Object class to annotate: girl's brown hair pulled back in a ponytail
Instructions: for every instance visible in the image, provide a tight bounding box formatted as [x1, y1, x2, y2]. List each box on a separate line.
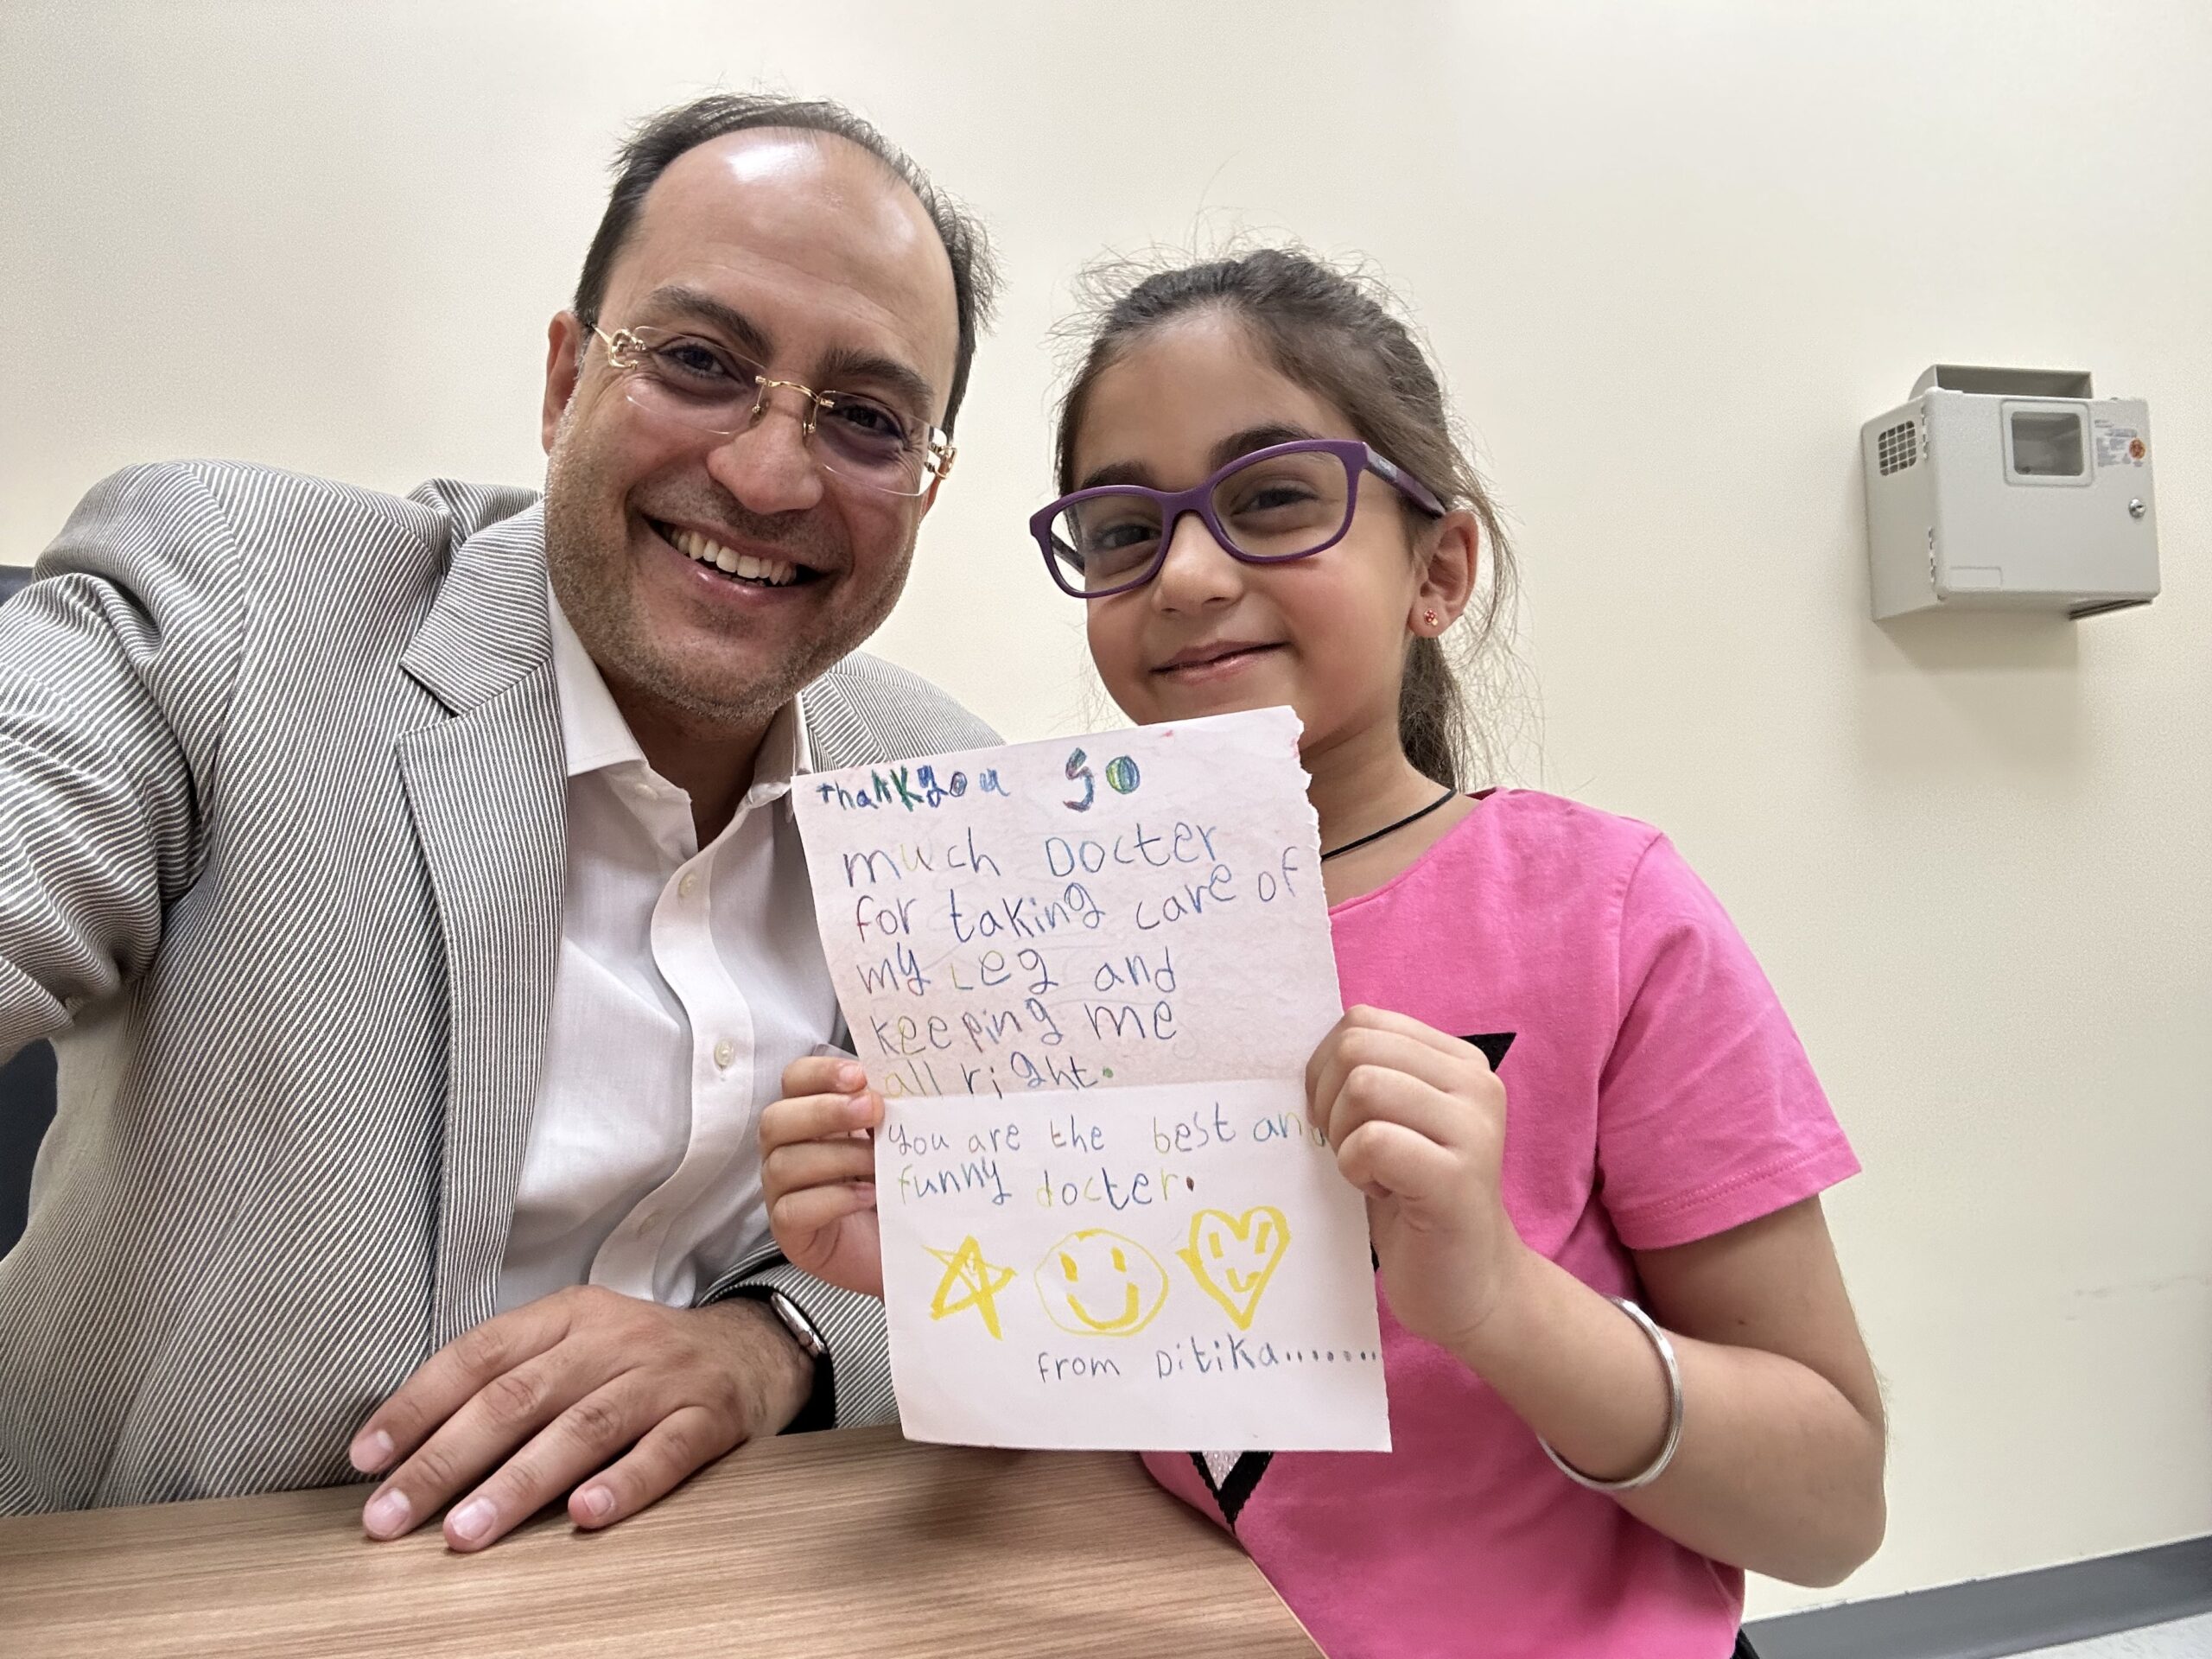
[1055, 248, 1513, 787]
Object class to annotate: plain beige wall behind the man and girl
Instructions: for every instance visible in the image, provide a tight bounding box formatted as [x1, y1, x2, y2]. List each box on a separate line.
[0, 0, 2212, 1611]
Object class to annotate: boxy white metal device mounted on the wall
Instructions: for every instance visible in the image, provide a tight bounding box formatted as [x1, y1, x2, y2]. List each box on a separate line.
[1858, 363, 2159, 621]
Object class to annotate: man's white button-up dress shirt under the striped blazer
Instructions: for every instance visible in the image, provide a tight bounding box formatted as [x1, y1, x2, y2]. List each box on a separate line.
[500, 600, 838, 1310]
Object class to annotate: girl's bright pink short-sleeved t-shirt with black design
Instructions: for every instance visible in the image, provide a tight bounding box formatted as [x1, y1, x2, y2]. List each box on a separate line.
[1146, 790, 1858, 1659]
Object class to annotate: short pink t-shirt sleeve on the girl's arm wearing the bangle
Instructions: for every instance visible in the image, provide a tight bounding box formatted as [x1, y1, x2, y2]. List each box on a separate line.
[1597, 836, 1858, 1249]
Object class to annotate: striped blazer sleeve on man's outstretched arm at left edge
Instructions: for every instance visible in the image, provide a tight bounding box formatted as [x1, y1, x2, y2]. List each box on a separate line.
[0, 465, 244, 1059]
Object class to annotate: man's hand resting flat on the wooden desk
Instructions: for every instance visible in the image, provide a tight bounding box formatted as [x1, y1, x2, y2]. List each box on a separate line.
[352, 1285, 814, 1551]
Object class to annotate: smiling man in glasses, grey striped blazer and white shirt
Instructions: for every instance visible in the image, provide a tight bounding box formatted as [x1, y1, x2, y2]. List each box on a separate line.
[0, 95, 993, 1548]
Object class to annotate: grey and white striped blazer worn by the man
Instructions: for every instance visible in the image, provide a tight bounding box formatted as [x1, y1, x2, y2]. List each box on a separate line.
[0, 462, 993, 1510]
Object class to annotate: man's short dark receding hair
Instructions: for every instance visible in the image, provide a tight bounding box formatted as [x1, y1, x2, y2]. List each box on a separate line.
[575, 93, 998, 431]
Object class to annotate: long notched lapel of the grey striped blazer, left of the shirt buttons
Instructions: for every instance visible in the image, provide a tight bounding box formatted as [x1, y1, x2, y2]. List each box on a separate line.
[398, 509, 569, 1347]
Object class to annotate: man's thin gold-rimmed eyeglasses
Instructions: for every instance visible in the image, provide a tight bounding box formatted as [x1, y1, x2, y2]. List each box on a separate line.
[591, 325, 953, 495]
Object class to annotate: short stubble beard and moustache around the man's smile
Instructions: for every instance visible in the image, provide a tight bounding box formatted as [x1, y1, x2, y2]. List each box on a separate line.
[544, 429, 918, 732]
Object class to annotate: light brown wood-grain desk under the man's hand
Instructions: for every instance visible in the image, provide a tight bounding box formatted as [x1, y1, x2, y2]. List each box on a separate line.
[0, 1429, 1316, 1659]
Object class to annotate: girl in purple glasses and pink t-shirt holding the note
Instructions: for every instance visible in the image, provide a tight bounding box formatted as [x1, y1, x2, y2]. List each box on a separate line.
[761, 252, 1883, 1659]
